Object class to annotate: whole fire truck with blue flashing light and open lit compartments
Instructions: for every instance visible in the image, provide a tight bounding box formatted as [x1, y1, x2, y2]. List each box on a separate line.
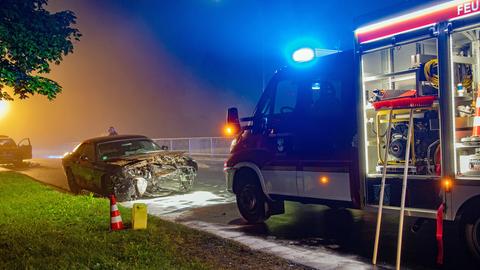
[224, 0, 480, 268]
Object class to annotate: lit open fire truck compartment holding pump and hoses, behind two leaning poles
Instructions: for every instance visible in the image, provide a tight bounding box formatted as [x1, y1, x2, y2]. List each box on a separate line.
[360, 36, 441, 211]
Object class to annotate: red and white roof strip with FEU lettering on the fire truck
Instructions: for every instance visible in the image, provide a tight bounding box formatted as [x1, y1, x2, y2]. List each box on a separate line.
[355, 0, 480, 43]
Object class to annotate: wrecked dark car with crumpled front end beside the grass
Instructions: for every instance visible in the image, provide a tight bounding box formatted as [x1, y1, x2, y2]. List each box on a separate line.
[62, 135, 198, 201]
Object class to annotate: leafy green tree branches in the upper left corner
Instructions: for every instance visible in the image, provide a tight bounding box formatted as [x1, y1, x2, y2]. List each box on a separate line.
[0, 0, 81, 100]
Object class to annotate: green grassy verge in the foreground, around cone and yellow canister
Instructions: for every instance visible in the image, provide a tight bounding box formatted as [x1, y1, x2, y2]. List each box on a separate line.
[0, 172, 306, 269]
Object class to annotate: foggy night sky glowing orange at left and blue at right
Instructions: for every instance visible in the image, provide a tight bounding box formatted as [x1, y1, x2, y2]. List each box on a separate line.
[0, 0, 442, 151]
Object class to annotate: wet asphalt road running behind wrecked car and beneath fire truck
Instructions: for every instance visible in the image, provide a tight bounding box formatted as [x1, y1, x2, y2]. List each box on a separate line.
[1, 157, 480, 269]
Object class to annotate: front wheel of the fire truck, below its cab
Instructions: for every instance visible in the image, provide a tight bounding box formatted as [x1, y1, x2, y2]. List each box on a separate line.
[236, 181, 268, 224]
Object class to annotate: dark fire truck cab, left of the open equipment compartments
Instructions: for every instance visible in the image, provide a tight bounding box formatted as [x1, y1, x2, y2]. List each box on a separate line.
[225, 51, 361, 223]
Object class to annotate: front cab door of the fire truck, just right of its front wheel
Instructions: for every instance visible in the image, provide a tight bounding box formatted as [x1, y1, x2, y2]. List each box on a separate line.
[261, 79, 300, 196]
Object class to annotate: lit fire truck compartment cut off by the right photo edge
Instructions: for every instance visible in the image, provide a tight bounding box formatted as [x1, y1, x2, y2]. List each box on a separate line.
[450, 25, 480, 179]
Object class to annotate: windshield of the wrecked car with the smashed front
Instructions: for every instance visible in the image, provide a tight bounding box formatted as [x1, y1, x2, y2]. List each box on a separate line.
[98, 139, 161, 161]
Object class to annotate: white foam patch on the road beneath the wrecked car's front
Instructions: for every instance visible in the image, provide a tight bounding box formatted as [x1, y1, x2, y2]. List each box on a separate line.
[122, 191, 235, 217]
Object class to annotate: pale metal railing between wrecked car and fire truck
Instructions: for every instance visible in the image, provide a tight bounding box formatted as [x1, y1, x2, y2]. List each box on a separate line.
[153, 137, 232, 156]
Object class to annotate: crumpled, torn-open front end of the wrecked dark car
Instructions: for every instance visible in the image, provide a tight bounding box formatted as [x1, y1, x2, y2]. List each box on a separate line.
[110, 152, 198, 201]
